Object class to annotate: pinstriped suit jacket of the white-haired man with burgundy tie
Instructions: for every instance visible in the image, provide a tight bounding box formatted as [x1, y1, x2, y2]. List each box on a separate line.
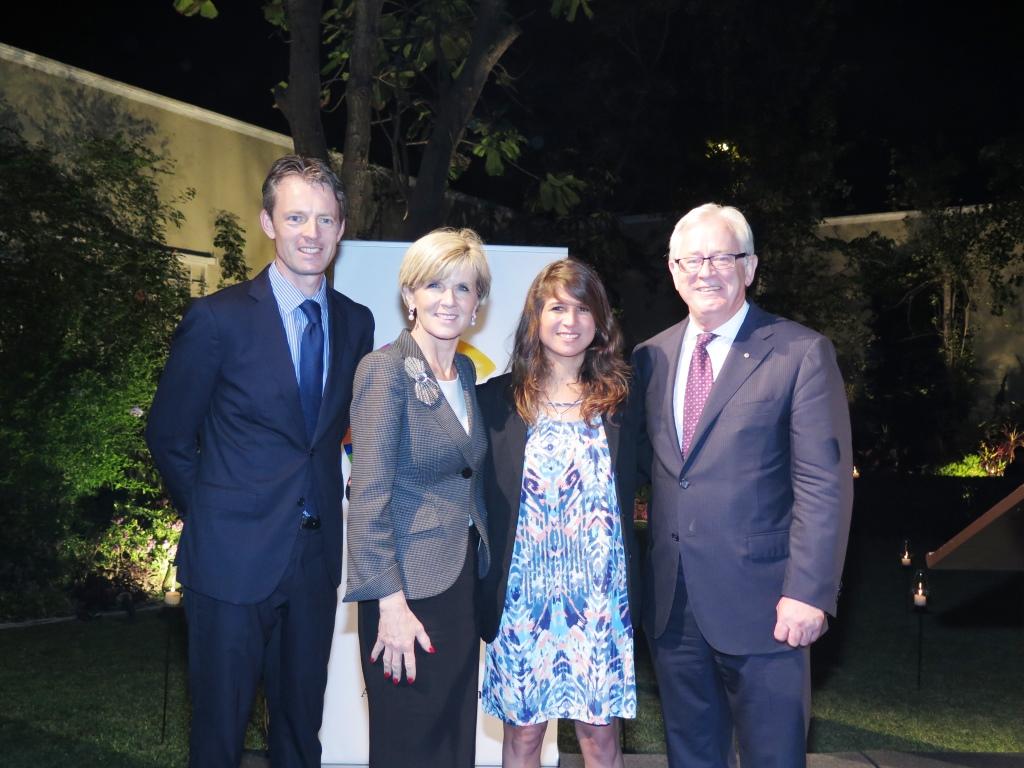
[633, 304, 853, 654]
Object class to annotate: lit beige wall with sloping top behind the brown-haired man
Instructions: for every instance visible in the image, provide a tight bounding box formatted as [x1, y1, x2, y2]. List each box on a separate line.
[0, 44, 292, 289]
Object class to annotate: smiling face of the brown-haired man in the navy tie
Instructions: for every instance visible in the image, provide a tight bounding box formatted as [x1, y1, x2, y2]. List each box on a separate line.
[259, 175, 345, 296]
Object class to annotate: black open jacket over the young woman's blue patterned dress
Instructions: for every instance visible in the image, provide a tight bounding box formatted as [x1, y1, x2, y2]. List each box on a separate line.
[477, 374, 640, 642]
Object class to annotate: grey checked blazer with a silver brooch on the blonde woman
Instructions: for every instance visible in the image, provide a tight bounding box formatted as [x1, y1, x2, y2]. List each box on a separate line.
[345, 331, 490, 602]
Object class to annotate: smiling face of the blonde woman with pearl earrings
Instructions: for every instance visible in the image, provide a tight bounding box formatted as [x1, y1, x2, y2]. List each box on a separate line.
[401, 266, 479, 341]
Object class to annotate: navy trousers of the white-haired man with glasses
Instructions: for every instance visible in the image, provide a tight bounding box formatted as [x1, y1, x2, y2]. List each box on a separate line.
[650, 567, 811, 768]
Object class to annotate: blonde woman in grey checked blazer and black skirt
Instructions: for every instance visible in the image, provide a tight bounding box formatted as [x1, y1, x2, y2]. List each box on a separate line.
[345, 229, 490, 768]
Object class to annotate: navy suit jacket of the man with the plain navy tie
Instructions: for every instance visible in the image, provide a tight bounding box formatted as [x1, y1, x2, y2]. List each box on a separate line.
[145, 267, 374, 604]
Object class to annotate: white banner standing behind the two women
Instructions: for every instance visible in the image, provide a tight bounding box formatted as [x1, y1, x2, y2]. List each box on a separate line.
[319, 241, 568, 766]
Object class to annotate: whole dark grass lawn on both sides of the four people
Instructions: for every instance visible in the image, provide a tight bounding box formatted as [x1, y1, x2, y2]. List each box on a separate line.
[0, 541, 1024, 768]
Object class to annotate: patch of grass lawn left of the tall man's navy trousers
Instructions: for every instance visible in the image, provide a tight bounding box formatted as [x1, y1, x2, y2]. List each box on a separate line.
[0, 611, 188, 768]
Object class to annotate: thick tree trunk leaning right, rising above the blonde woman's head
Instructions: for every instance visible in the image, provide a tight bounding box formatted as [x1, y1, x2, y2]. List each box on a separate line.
[402, 0, 520, 240]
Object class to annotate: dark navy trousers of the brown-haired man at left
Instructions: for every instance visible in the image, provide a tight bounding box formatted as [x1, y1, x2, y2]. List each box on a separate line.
[184, 523, 338, 768]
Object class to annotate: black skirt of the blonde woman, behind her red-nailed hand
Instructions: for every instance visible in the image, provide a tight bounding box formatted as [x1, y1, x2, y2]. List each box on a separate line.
[358, 532, 480, 768]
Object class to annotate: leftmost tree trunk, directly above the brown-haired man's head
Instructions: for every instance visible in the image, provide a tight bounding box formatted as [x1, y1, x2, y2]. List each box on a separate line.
[273, 0, 328, 160]
